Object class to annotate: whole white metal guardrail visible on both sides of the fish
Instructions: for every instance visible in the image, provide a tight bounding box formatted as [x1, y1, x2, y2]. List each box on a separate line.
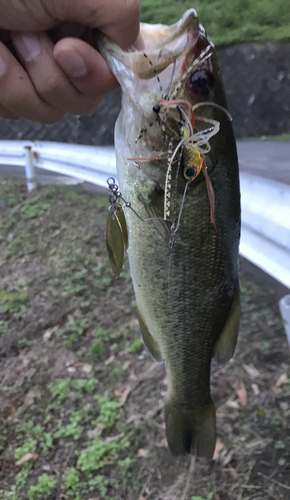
[0, 141, 290, 294]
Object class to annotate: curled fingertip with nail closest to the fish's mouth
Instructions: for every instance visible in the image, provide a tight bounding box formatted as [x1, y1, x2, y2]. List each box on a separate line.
[54, 38, 118, 100]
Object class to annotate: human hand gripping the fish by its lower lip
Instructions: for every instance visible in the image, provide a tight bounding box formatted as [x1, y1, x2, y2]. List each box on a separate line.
[0, 0, 140, 123]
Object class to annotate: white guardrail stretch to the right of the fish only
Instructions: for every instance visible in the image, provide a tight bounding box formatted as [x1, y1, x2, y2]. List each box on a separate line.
[240, 173, 290, 288]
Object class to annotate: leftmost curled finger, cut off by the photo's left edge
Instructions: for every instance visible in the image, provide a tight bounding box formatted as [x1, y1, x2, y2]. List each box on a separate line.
[0, 43, 63, 123]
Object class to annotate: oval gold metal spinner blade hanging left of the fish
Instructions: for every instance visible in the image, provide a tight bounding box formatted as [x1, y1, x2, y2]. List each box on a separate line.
[106, 207, 128, 278]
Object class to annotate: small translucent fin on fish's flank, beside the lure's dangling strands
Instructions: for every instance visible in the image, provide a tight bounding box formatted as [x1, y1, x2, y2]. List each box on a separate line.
[139, 187, 172, 242]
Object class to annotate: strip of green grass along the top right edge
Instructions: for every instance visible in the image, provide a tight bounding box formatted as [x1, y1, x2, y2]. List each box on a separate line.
[141, 0, 290, 45]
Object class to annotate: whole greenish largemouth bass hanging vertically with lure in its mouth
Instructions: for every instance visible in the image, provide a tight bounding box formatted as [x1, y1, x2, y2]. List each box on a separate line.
[96, 9, 240, 459]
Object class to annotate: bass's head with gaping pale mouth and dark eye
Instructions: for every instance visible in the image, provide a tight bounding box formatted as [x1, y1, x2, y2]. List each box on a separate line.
[97, 9, 231, 156]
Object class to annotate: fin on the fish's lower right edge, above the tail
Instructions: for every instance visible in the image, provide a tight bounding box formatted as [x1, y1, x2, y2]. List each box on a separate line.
[214, 288, 241, 365]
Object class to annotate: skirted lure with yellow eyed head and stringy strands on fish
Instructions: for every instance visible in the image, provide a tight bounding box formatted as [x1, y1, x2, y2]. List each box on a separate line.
[128, 47, 231, 249]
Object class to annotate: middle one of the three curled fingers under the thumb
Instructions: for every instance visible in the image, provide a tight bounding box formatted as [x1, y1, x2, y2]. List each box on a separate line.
[12, 33, 103, 114]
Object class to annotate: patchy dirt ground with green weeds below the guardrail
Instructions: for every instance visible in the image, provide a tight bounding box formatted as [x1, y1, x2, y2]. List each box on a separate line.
[0, 179, 290, 500]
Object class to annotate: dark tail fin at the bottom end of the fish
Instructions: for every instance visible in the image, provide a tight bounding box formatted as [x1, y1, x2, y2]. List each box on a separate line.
[165, 400, 216, 460]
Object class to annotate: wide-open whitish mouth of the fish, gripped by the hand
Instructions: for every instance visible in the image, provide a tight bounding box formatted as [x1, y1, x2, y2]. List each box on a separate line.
[97, 9, 211, 97]
